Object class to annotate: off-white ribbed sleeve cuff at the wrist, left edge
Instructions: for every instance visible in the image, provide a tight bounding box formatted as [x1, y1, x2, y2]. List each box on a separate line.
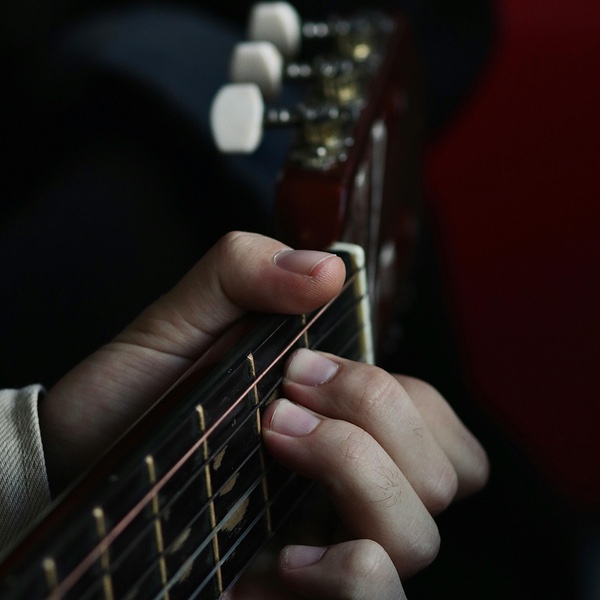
[0, 385, 50, 554]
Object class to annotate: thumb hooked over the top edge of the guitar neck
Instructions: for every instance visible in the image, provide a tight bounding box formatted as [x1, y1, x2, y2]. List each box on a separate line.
[40, 232, 344, 480]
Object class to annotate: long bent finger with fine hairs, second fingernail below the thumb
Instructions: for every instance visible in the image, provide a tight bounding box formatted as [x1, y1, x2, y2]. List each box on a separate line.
[263, 400, 439, 575]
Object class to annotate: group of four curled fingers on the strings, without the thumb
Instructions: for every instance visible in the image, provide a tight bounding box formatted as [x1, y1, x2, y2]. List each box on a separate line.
[231, 349, 488, 600]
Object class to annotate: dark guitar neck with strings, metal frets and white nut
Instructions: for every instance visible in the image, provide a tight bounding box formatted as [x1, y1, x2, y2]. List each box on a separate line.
[0, 245, 370, 600]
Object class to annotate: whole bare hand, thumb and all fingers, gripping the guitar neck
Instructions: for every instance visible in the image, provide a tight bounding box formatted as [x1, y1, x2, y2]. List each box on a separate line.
[40, 232, 488, 600]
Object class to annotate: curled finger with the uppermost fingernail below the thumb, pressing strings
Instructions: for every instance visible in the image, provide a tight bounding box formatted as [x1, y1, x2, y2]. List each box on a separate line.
[284, 349, 457, 514]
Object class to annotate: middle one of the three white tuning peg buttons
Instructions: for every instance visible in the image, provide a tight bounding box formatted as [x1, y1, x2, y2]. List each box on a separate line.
[229, 42, 283, 98]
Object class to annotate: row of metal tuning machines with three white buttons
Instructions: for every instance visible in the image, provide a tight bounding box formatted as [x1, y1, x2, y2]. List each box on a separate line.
[211, 2, 395, 170]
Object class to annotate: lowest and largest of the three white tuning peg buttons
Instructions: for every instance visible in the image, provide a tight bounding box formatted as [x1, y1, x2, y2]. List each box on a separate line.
[210, 83, 265, 154]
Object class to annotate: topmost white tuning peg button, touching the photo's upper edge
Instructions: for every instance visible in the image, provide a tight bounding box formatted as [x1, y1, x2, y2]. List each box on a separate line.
[248, 2, 302, 58]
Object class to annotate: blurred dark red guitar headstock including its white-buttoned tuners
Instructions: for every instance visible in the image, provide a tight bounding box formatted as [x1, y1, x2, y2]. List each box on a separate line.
[213, 2, 422, 348]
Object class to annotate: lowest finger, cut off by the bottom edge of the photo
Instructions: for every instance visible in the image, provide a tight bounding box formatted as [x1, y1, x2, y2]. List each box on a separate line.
[279, 540, 406, 600]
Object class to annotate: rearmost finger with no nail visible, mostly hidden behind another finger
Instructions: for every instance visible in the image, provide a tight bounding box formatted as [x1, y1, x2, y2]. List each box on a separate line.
[394, 375, 489, 498]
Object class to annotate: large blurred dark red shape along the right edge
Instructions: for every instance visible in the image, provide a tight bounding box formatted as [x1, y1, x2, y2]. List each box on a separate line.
[427, 0, 600, 510]
